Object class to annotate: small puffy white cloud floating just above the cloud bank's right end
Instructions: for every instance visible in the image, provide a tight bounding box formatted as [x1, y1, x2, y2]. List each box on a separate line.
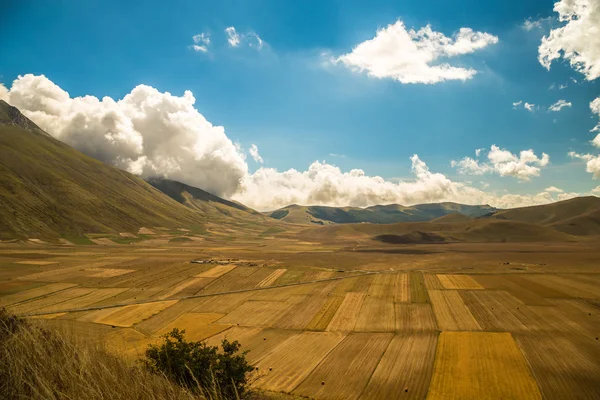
[450, 145, 550, 181]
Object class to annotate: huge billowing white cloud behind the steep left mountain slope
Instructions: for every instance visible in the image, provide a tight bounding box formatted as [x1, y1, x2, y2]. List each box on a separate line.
[3, 75, 248, 196]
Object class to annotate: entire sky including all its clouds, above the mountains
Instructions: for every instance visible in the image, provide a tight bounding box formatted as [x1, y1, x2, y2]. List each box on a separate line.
[0, 0, 600, 210]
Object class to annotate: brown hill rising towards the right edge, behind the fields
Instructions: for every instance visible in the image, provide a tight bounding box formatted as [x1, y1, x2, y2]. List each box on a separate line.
[488, 196, 600, 236]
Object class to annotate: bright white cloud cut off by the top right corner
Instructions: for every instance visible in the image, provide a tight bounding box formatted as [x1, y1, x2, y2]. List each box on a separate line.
[538, 0, 600, 80]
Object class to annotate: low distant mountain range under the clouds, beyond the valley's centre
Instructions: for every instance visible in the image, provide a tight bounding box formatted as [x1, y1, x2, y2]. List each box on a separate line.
[265, 202, 497, 225]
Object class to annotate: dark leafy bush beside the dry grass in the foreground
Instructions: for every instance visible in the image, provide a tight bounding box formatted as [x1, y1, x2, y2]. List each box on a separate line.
[144, 328, 254, 399]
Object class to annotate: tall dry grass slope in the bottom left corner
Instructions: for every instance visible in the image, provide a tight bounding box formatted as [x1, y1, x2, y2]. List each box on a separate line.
[0, 310, 197, 400]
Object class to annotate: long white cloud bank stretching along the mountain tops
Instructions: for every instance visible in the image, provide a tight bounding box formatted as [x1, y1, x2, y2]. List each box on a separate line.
[0, 75, 580, 210]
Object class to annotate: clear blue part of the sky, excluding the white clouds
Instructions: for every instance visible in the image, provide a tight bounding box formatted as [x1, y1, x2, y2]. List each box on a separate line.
[0, 0, 600, 211]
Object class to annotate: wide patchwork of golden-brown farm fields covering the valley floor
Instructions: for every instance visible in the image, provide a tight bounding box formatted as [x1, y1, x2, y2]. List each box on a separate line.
[0, 239, 600, 400]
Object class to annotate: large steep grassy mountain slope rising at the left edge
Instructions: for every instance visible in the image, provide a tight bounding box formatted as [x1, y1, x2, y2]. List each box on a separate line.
[0, 101, 260, 239]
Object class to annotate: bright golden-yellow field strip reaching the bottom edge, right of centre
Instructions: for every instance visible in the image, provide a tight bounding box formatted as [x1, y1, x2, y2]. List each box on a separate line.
[427, 332, 542, 400]
